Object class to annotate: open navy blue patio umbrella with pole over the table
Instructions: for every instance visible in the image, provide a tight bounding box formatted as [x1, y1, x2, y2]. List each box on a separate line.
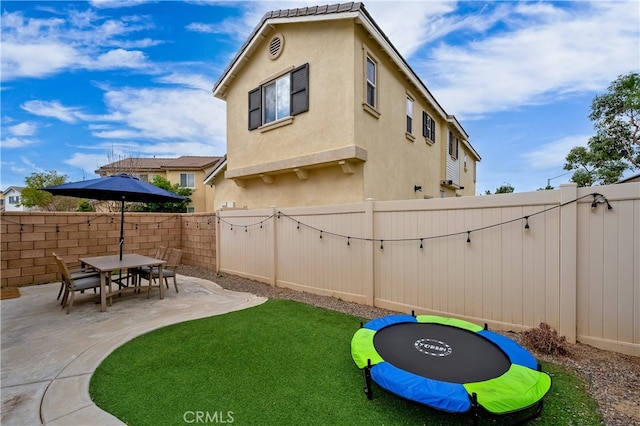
[42, 173, 186, 260]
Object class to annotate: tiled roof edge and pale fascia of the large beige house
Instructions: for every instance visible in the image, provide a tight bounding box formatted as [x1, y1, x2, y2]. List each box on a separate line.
[213, 2, 481, 160]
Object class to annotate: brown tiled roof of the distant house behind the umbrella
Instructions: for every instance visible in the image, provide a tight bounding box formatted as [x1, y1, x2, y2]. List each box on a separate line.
[96, 155, 220, 175]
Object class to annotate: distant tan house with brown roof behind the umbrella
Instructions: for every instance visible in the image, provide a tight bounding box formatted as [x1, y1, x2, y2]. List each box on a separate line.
[96, 155, 221, 213]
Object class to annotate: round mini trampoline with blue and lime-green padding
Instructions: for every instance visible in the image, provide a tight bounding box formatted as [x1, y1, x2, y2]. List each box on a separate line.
[351, 315, 551, 415]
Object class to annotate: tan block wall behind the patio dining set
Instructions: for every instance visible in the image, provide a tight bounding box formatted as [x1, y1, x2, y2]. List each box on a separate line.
[0, 212, 216, 288]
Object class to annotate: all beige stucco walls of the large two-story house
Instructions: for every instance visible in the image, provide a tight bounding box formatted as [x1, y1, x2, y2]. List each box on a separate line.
[213, 15, 475, 209]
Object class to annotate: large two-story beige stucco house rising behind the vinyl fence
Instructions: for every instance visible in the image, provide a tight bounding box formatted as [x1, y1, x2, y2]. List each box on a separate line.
[205, 3, 480, 209]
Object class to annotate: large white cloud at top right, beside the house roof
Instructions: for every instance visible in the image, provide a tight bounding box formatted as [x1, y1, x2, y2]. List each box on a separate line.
[416, 2, 640, 116]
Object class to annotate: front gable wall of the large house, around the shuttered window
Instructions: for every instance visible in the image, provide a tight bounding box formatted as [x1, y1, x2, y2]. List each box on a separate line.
[226, 21, 353, 170]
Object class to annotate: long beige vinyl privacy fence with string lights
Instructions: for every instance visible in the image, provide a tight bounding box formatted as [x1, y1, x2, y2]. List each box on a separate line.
[216, 183, 640, 356]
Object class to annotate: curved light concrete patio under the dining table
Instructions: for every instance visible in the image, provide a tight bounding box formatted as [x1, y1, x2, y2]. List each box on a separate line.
[0, 275, 266, 426]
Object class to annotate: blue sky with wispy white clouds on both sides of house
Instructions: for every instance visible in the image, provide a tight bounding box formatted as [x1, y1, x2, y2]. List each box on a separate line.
[0, 0, 640, 194]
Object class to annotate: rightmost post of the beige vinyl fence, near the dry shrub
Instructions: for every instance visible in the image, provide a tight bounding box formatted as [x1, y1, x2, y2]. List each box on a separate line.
[558, 183, 578, 343]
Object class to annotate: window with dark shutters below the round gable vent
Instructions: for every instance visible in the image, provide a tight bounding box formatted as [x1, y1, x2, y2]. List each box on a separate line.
[249, 64, 309, 130]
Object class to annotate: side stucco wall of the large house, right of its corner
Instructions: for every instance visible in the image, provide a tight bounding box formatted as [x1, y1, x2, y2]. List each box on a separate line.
[353, 26, 446, 200]
